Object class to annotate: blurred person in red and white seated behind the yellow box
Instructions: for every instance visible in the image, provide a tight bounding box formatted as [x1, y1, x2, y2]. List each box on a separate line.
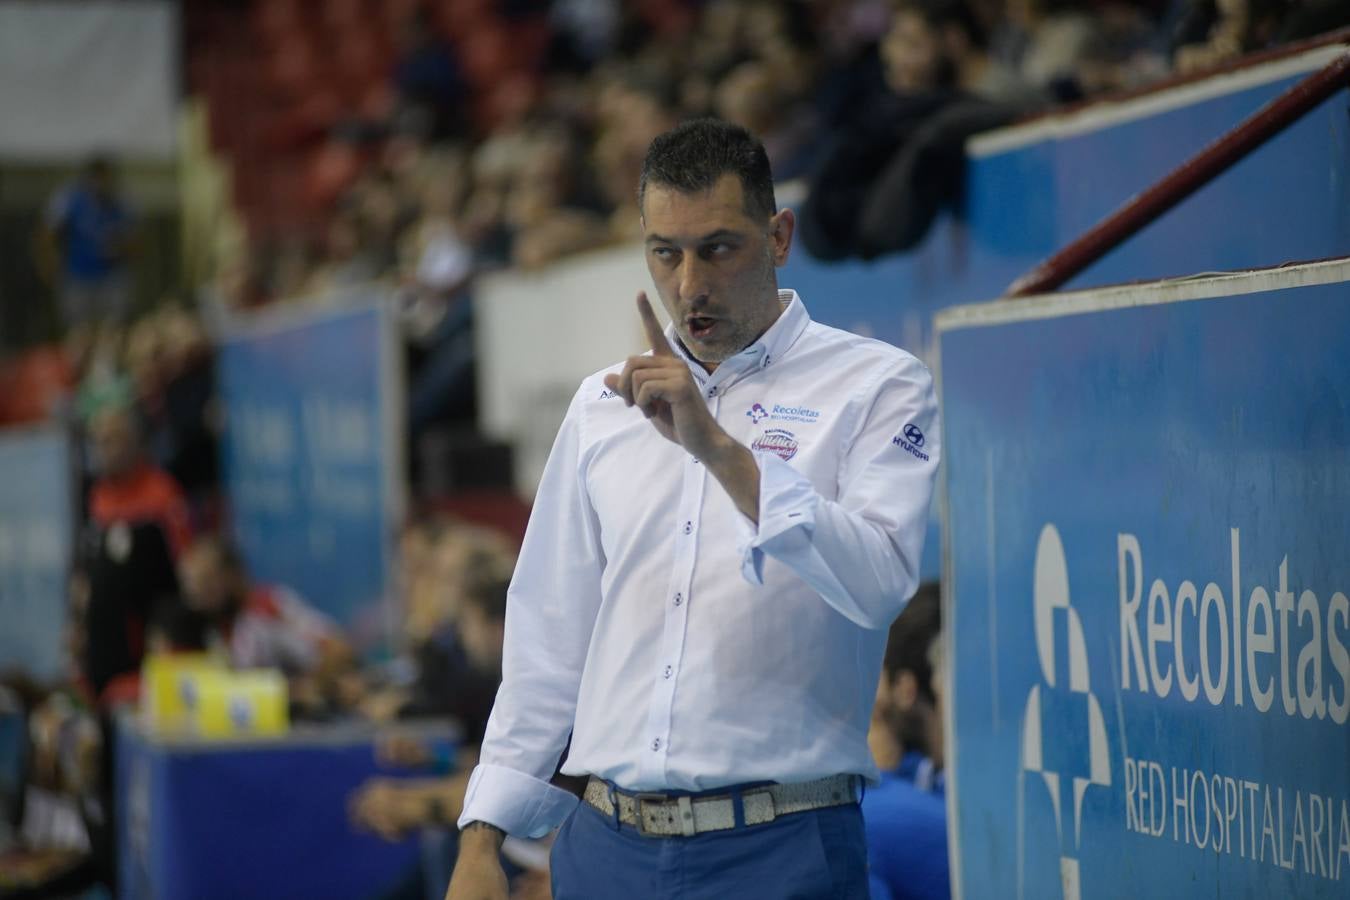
[180, 536, 348, 687]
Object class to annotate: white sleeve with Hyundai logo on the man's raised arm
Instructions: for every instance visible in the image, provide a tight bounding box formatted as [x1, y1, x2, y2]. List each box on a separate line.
[741, 356, 941, 629]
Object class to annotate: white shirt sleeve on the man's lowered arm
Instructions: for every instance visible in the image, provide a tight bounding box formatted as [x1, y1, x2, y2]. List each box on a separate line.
[459, 391, 603, 838]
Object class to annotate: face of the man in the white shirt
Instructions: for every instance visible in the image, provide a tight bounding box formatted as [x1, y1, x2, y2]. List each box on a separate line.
[643, 174, 794, 371]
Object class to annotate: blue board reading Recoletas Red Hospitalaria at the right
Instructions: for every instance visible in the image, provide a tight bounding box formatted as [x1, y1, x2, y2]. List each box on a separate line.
[938, 262, 1350, 899]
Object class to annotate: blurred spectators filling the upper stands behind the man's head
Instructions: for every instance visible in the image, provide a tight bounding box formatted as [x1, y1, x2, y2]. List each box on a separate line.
[205, 0, 1350, 306]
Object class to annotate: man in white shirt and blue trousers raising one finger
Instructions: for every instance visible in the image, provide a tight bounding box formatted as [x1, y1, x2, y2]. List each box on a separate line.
[448, 120, 938, 900]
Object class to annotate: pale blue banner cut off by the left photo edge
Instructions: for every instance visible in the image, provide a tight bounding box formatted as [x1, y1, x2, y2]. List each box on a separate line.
[0, 429, 74, 679]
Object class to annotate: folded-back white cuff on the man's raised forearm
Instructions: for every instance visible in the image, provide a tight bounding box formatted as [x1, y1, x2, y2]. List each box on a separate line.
[740, 451, 821, 584]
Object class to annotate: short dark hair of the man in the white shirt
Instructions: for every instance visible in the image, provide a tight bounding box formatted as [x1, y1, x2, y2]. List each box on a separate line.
[637, 119, 778, 219]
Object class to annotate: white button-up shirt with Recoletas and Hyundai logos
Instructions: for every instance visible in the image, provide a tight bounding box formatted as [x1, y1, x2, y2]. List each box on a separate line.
[460, 291, 938, 837]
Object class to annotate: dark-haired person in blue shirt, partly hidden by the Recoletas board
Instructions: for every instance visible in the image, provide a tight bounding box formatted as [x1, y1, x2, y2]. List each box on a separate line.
[863, 582, 952, 900]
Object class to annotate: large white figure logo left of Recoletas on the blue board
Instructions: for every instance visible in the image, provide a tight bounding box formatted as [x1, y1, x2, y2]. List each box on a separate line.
[1018, 525, 1111, 900]
